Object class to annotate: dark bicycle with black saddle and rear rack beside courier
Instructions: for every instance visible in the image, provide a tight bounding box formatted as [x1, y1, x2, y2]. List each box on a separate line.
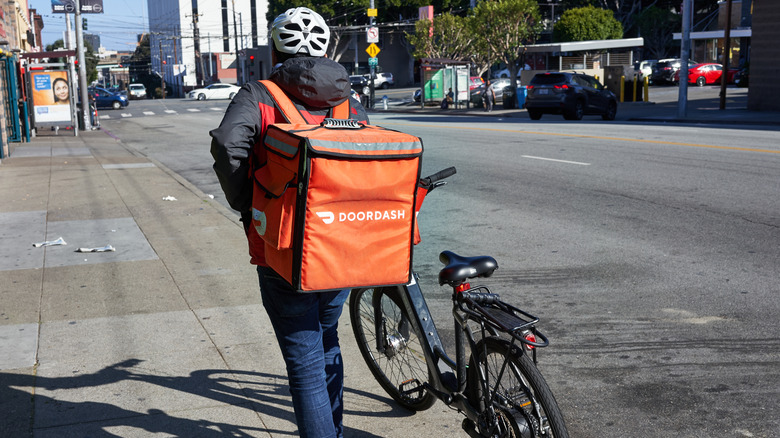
[349, 167, 568, 438]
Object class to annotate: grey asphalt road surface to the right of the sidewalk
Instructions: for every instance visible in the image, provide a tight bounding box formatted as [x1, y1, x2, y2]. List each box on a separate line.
[102, 96, 780, 437]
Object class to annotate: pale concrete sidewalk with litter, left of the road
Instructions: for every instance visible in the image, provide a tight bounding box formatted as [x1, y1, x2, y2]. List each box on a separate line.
[0, 131, 462, 437]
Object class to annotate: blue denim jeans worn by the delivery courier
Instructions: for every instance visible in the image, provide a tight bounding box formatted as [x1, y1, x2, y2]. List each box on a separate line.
[257, 266, 349, 438]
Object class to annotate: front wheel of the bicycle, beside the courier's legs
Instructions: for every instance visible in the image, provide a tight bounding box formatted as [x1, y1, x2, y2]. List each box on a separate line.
[349, 287, 436, 411]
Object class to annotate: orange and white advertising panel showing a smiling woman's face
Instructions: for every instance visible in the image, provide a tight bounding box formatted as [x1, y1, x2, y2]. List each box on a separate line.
[30, 71, 72, 123]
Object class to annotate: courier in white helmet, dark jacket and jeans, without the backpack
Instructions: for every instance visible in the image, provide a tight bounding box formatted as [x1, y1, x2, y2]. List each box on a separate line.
[210, 7, 368, 437]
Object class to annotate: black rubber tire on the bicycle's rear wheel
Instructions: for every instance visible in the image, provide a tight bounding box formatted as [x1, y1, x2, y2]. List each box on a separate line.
[466, 337, 569, 438]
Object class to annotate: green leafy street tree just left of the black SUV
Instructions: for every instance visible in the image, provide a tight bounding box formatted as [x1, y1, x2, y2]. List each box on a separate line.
[471, 0, 541, 89]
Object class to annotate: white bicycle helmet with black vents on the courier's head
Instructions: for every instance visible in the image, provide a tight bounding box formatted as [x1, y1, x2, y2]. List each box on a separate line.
[271, 7, 330, 56]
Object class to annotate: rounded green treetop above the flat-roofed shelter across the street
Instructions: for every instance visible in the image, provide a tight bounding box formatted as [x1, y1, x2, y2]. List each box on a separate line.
[553, 6, 623, 41]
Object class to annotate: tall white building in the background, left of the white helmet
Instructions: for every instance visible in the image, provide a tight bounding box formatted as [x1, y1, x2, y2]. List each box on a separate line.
[148, 0, 268, 96]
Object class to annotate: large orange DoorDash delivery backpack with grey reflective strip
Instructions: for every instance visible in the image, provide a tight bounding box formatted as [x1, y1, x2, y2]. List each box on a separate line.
[250, 81, 423, 292]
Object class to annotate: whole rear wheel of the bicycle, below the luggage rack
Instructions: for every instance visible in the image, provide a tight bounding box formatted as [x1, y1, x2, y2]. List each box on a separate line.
[466, 337, 569, 438]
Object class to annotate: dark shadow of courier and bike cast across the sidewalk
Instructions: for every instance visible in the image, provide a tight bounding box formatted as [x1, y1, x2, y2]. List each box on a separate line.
[0, 359, 413, 438]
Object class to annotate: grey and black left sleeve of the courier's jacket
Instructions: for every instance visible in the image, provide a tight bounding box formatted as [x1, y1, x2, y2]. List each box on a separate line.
[209, 85, 262, 213]
